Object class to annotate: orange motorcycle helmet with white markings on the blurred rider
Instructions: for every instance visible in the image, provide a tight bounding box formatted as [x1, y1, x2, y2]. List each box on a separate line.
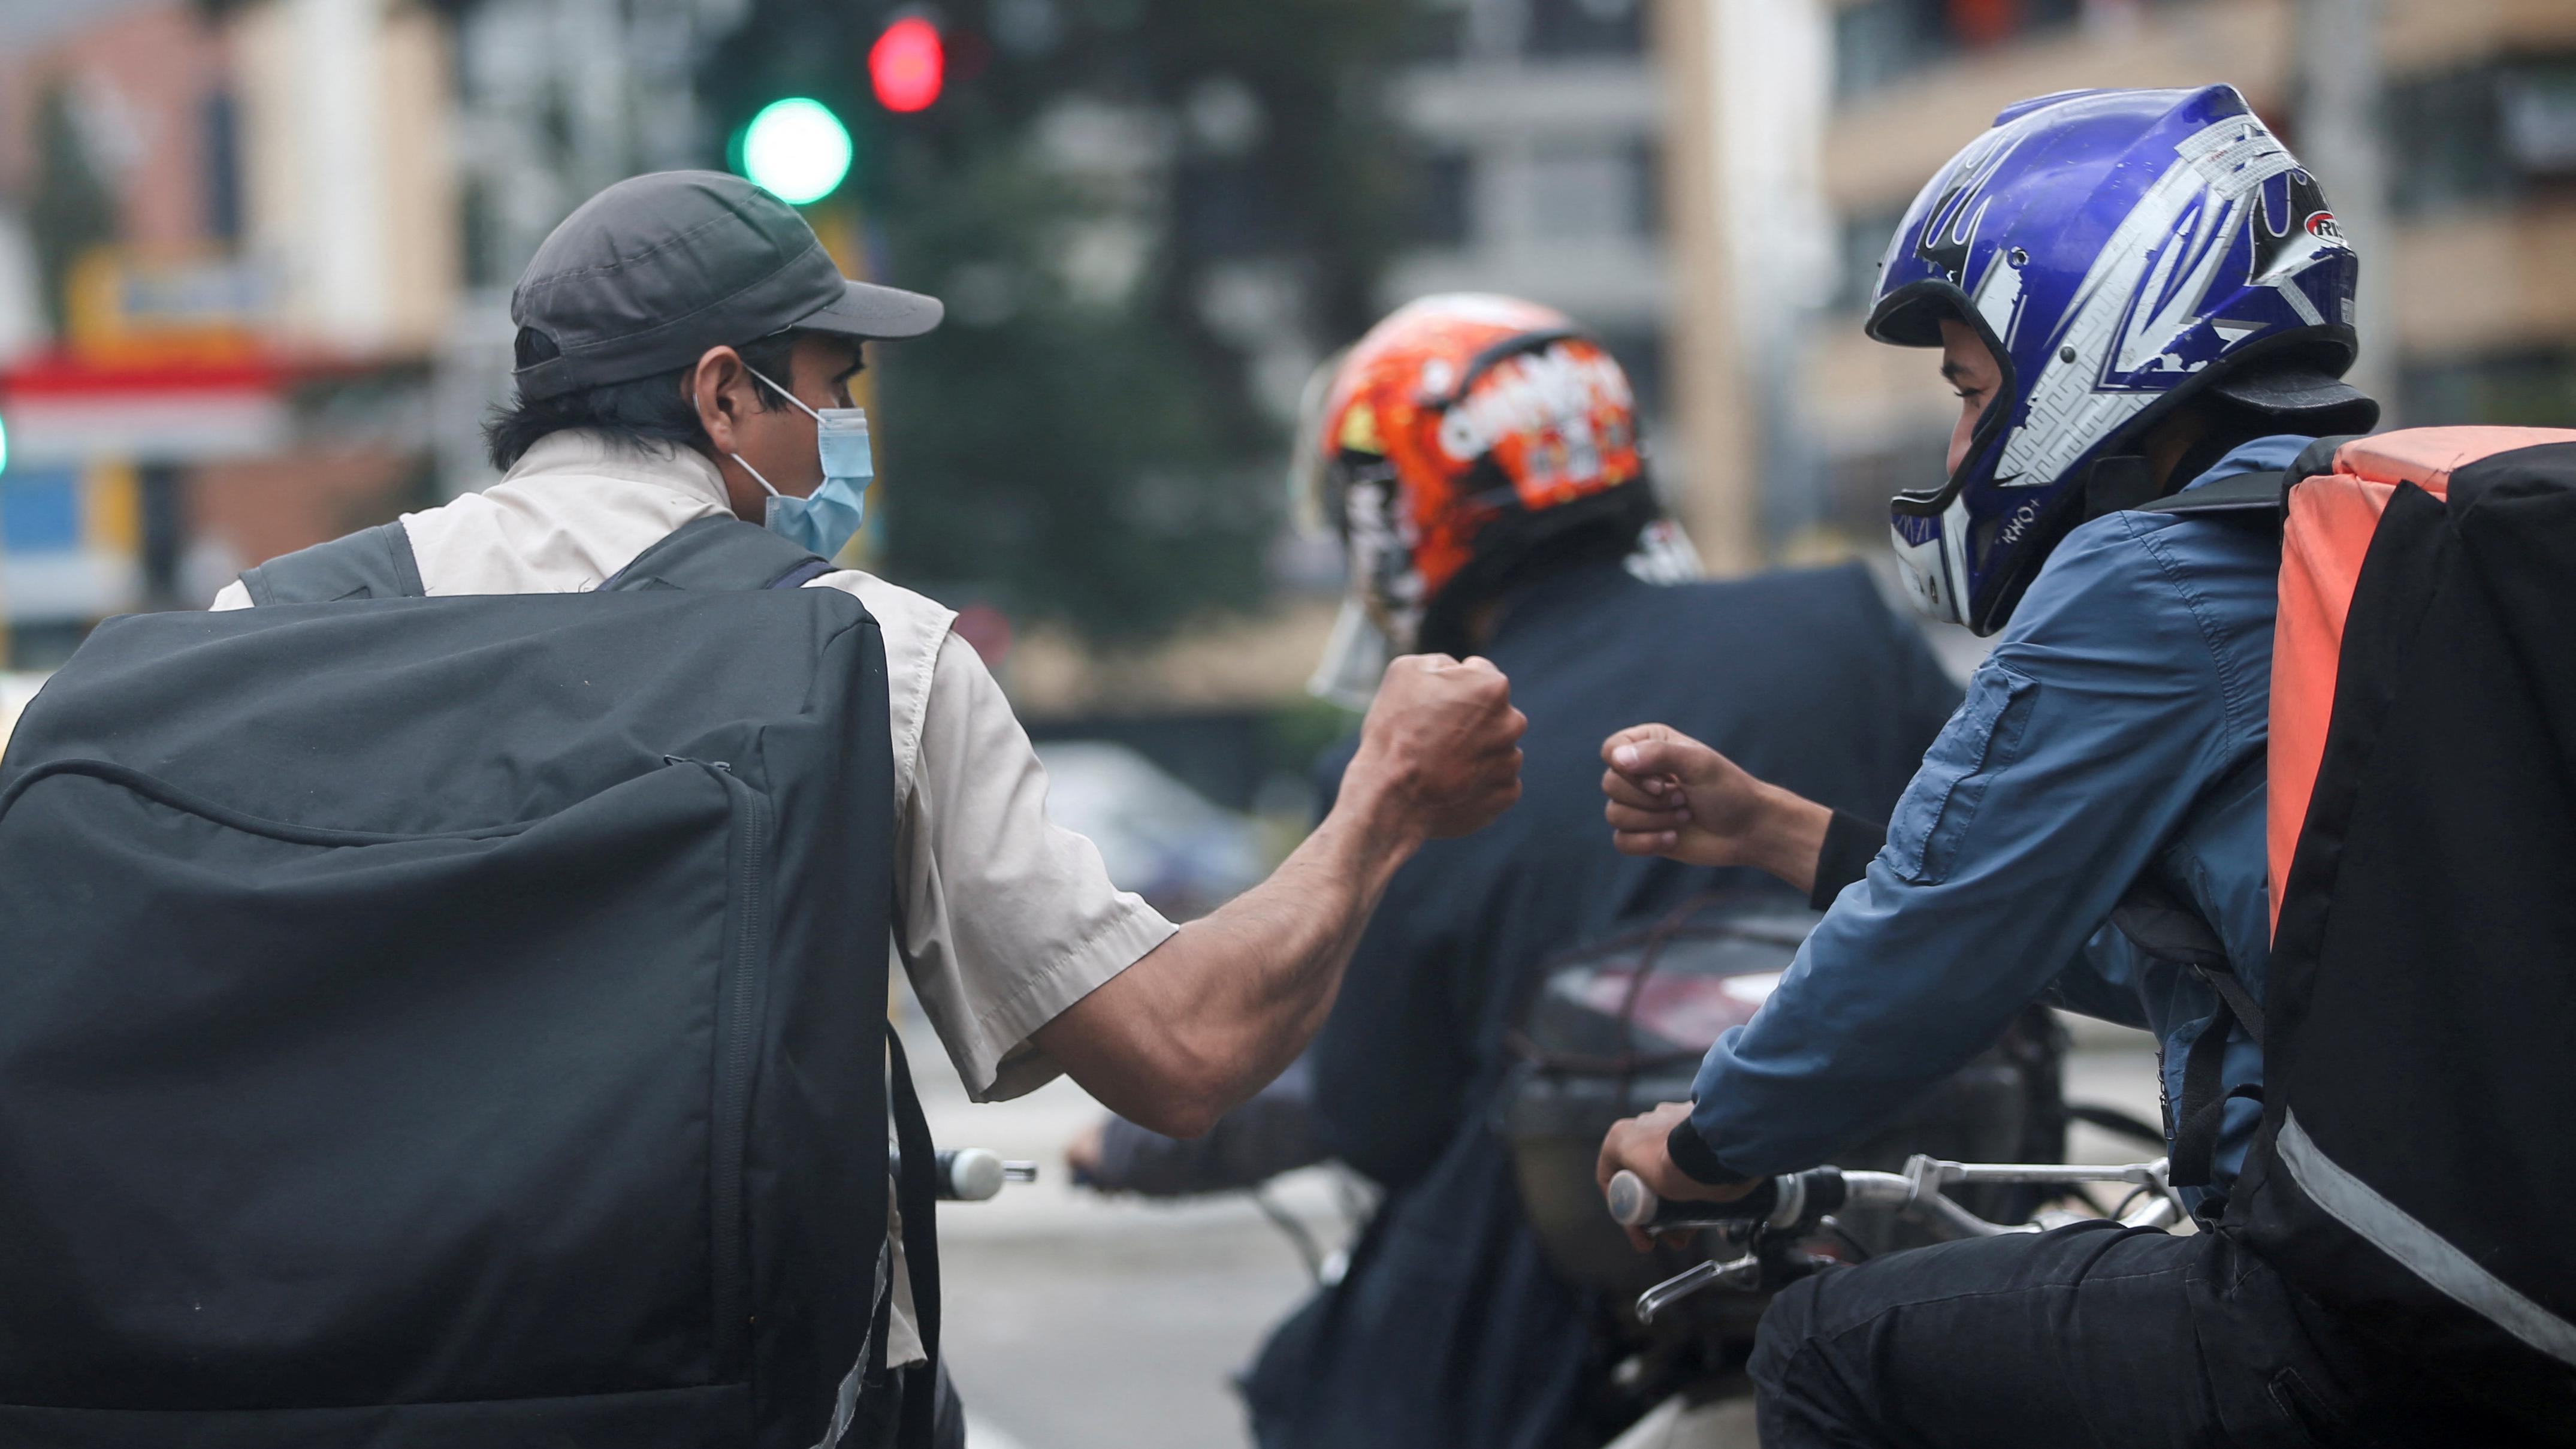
[1298, 294, 1659, 653]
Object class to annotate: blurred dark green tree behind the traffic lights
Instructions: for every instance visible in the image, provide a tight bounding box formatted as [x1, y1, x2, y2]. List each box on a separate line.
[700, 0, 1417, 645]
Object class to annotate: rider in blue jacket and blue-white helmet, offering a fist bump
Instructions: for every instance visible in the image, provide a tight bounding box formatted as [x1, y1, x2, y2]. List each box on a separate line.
[1600, 87, 2493, 1449]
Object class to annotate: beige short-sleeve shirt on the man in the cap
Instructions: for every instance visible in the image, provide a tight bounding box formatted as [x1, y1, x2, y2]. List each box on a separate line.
[214, 431, 1174, 1364]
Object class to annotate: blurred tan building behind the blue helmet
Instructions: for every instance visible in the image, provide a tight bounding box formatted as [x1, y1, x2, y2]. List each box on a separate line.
[1659, 0, 2576, 557]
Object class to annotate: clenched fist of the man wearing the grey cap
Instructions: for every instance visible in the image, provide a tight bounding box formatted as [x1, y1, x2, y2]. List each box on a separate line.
[1342, 655, 1530, 838]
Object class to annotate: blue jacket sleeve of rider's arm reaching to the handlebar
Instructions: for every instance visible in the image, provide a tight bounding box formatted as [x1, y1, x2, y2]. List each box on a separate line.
[1690, 513, 2262, 1178]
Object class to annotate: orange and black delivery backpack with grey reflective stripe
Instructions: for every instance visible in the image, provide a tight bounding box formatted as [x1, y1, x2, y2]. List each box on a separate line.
[2151, 428, 2576, 1431]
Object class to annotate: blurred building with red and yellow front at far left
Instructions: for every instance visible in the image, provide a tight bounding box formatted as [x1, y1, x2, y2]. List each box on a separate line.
[0, 0, 458, 668]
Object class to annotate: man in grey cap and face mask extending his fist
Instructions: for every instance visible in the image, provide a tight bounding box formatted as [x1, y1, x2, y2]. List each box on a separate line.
[216, 173, 1523, 1441]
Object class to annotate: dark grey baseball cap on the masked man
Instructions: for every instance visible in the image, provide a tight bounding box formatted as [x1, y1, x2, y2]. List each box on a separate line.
[510, 170, 940, 400]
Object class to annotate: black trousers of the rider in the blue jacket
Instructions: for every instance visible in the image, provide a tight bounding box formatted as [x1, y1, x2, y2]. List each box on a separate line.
[1751, 1222, 2530, 1449]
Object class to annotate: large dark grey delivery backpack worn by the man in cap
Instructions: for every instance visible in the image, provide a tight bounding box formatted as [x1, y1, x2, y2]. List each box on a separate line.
[0, 518, 938, 1449]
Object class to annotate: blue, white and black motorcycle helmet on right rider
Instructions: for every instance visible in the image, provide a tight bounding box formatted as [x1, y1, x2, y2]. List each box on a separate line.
[1868, 85, 2378, 634]
